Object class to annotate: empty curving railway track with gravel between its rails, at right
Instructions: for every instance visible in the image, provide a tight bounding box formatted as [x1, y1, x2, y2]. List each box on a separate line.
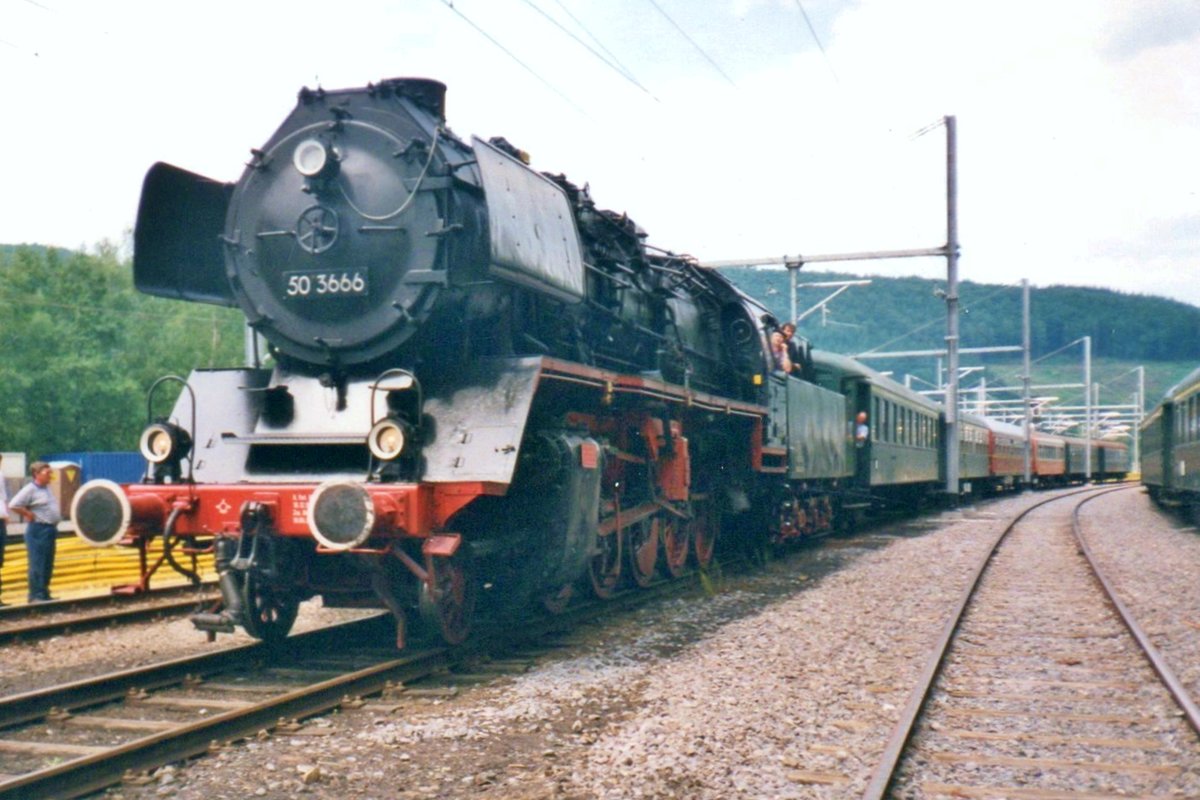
[863, 487, 1200, 800]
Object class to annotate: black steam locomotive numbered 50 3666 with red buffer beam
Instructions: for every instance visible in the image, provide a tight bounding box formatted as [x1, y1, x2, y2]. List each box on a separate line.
[73, 79, 777, 644]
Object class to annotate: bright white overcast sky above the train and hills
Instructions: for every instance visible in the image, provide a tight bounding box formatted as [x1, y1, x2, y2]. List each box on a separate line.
[0, 0, 1200, 305]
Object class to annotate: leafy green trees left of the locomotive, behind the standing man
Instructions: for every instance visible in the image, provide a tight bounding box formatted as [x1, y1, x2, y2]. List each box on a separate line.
[0, 243, 241, 457]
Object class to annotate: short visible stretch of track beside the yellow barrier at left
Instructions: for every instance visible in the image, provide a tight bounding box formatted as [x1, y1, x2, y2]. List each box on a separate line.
[0, 584, 220, 645]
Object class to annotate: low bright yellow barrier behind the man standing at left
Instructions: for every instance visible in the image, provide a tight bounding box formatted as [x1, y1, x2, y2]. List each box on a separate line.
[0, 532, 216, 603]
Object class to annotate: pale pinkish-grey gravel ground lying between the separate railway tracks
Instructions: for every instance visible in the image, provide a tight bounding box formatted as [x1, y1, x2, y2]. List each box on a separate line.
[7, 491, 1200, 800]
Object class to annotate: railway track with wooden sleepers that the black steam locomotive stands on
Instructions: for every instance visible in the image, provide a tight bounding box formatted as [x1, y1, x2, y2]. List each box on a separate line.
[0, 568, 698, 800]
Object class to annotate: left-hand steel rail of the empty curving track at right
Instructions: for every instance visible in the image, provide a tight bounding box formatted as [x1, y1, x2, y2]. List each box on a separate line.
[862, 486, 1128, 800]
